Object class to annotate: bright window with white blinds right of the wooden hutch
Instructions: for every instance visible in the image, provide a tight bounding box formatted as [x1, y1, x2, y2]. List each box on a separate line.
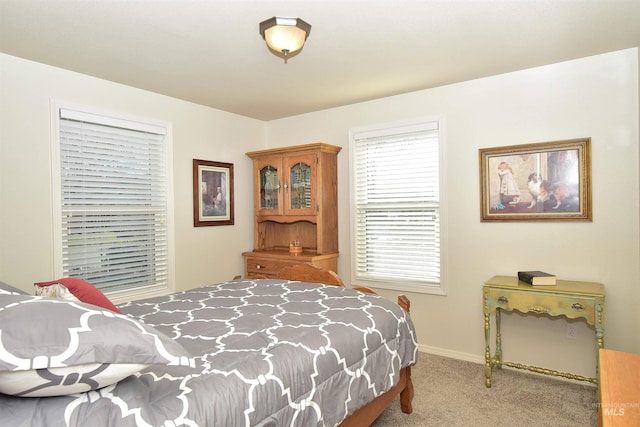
[351, 120, 444, 294]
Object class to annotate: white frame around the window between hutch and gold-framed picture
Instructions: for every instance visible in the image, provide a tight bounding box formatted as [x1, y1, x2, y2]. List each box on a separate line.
[349, 116, 447, 295]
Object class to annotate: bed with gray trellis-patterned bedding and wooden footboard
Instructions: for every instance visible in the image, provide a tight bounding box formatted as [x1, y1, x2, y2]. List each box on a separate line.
[0, 270, 418, 426]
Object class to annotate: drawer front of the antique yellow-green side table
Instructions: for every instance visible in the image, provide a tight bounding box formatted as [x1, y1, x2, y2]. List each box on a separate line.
[485, 289, 596, 325]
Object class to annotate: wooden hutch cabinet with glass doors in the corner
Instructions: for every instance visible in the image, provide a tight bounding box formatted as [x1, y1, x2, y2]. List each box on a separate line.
[242, 143, 341, 277]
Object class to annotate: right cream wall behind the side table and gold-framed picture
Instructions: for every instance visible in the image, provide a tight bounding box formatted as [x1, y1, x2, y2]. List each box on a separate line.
[267, 49, 640, 376]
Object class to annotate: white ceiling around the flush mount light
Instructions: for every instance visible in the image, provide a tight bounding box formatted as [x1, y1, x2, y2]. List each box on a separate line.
[0, 0, 640, 120]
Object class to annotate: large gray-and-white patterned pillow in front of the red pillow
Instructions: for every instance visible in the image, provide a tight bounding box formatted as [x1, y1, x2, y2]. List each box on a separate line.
[0, 293, 193, 396]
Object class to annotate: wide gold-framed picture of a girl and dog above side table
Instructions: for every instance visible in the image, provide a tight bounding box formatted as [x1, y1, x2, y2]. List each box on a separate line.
[479, 138, 592, 222]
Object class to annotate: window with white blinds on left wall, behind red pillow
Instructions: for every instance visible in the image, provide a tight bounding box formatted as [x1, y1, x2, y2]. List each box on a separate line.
[52, 105, 173, 299]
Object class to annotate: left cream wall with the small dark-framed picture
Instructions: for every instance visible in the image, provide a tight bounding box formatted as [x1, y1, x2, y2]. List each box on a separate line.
[0, 54, 265, 292]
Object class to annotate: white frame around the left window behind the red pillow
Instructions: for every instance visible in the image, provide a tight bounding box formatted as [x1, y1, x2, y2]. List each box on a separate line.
[50, 99, 175, 304]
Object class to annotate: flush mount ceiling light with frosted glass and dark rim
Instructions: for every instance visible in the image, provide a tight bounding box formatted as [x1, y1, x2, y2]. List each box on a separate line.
[260, 16, 311, 64]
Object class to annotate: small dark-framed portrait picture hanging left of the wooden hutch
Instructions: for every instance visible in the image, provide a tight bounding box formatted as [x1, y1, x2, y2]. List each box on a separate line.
[193, 159, 238, 227]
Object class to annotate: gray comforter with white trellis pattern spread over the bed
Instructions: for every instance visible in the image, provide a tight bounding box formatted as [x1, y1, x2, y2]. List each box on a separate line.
[0, 279, 418, 427]
